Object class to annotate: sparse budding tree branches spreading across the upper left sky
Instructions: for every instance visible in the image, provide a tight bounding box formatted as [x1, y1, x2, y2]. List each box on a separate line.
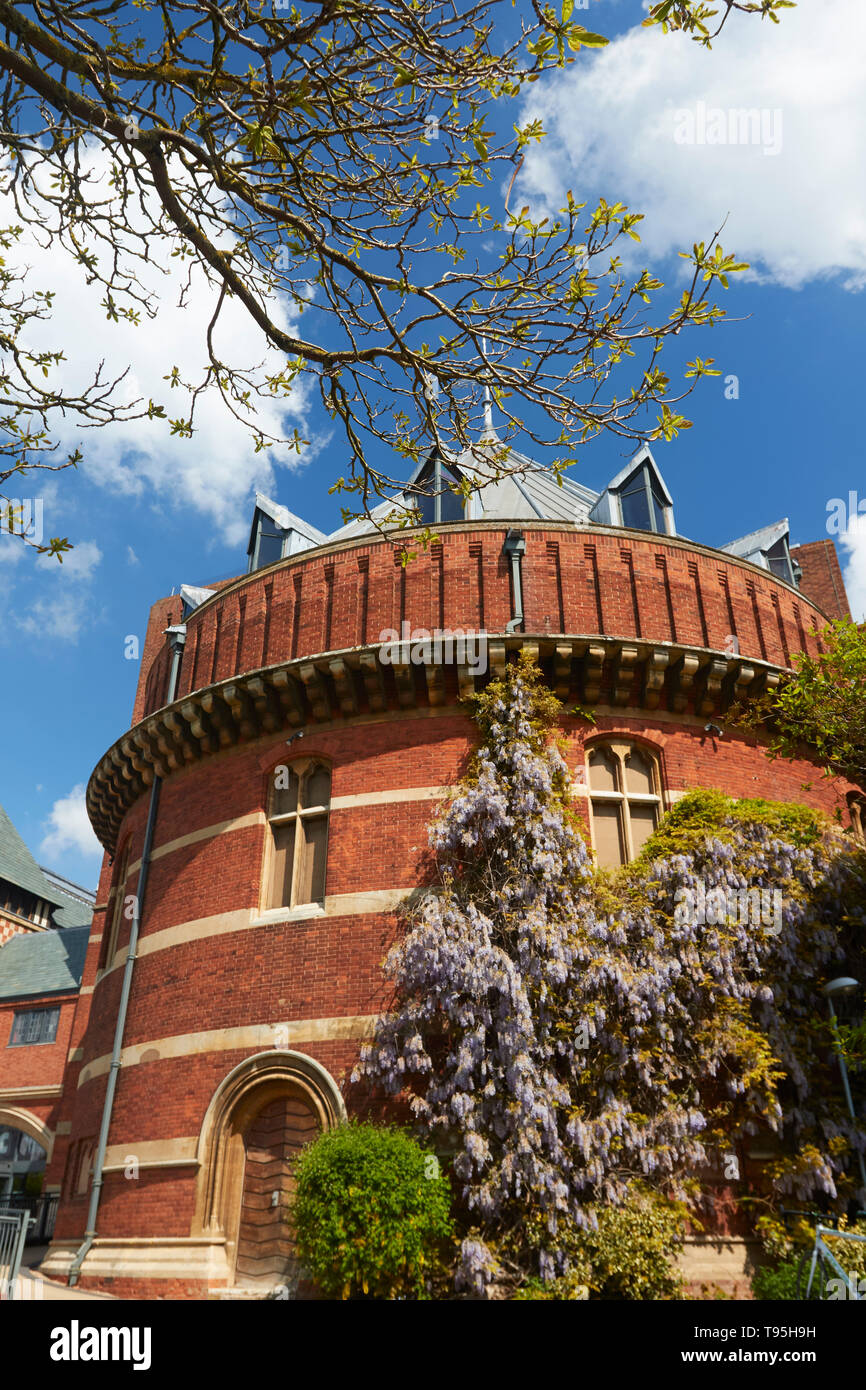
[0, 0, 788, 553]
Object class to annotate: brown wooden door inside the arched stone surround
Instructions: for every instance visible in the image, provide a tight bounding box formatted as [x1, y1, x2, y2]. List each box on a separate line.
[235, 1095, 318, 1286]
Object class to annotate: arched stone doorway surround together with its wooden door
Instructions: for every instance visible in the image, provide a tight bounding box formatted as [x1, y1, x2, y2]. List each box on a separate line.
[192, 1051, 346, 1286]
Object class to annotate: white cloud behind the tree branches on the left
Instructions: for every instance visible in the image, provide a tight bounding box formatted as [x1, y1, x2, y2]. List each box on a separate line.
[0, 150, 311, 544]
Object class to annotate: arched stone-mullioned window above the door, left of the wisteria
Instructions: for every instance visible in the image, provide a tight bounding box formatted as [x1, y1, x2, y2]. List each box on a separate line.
[265, 759, 331, 908]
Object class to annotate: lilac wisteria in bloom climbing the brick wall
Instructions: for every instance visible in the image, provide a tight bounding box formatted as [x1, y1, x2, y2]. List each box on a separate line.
[357, 660, 866, 1295]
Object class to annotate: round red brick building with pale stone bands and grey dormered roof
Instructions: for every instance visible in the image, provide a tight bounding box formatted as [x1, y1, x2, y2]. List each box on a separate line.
[32, 450, 859, 1297]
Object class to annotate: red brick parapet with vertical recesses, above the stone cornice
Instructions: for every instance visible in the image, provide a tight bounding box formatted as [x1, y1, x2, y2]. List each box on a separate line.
[133, 523, 844, 723]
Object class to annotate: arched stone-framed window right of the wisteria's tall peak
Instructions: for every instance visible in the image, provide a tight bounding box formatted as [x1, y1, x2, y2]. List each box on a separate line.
[587, 739, 662, 869]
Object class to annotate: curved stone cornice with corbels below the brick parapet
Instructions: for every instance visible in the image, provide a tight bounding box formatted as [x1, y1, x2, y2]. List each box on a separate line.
[88, 632, 784, 852]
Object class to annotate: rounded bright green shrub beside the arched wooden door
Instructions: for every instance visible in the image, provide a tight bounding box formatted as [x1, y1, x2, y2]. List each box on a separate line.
[292, 1123, 453, 1298]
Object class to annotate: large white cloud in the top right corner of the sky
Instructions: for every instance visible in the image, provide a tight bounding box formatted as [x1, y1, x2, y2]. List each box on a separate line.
[512, 0, 866, 289]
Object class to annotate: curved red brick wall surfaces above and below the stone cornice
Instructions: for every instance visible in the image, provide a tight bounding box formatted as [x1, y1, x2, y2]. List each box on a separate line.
[42, 524, 861, 1297]
